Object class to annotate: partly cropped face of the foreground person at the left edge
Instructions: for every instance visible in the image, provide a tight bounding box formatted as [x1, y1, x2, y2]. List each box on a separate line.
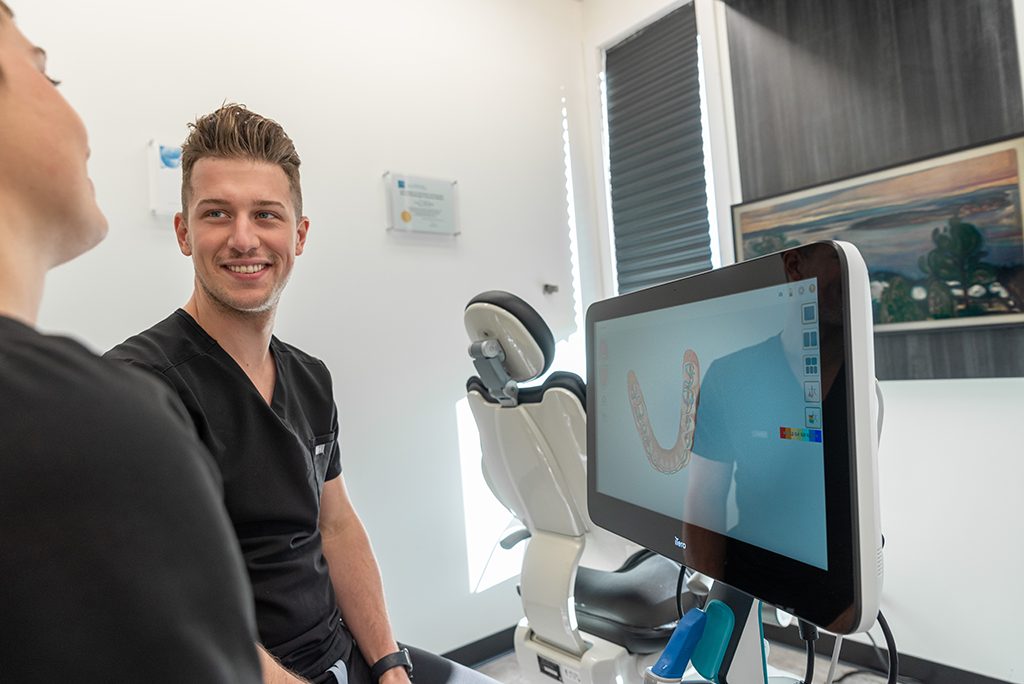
[0, 18, 106, 265]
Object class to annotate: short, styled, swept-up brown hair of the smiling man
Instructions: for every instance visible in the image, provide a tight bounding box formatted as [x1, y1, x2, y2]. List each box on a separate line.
[181, 104, 302, 221]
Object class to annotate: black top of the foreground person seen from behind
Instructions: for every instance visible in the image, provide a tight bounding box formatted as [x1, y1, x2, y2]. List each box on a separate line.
[0, 315, 262, 684]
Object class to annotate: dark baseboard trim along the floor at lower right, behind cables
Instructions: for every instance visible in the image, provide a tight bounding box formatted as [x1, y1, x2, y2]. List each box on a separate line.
[764, 625, 1011, 684]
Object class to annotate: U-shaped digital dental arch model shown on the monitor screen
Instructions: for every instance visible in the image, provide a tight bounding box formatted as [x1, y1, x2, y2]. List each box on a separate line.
[626, 349, 700, 475]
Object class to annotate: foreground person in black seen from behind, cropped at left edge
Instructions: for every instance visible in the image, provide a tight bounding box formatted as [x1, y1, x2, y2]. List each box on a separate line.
[0, 6, 260, 684]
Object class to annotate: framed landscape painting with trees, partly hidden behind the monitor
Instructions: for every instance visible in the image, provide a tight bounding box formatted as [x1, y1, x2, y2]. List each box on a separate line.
[732, 137, 1024, 332]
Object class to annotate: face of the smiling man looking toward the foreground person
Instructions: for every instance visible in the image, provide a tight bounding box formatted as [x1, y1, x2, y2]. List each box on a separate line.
[174, 158, 309, 314]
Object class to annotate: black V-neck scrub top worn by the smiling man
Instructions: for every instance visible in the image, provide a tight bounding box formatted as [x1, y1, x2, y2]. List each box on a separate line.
[106, 309, 352, 676]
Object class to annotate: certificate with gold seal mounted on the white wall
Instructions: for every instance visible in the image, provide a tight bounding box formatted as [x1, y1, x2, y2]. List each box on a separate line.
[384, 172, 459, 236]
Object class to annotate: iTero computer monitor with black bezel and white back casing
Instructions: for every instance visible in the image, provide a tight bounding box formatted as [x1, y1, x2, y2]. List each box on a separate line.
[587, 242, 882, 634]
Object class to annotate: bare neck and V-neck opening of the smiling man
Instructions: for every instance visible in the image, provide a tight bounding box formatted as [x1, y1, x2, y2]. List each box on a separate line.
[182, 286, 276, 403]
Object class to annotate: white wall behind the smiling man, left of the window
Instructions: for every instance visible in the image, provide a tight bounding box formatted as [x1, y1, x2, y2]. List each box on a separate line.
[19, 0, 589, 651]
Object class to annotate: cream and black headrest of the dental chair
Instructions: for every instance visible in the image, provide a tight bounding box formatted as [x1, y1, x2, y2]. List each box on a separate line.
[463, 290, 555, 382]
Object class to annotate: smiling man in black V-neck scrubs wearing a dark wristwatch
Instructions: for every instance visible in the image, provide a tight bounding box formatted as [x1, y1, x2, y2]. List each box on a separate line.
[108, 104, 490, 684]
